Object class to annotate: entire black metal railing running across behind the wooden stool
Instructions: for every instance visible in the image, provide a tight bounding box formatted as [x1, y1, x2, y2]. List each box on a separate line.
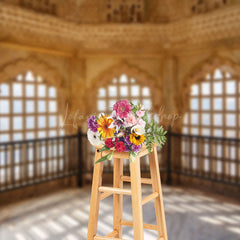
[0, 128, 240, 192]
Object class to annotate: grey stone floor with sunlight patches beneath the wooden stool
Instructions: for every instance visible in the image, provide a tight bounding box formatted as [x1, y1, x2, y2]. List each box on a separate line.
[0, 186, 240, 240]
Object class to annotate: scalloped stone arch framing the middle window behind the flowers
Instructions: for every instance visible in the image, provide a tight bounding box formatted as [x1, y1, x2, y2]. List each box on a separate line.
[88, 62, 162, 111]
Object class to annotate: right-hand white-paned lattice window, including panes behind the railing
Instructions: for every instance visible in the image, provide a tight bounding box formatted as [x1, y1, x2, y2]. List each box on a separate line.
[182, 69, 240, 179]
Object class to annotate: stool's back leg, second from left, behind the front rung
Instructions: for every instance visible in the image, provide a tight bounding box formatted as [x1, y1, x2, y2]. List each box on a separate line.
[113, 158, 123, 238]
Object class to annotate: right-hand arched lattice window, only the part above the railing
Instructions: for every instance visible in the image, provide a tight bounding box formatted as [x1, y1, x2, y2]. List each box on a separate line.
[183, 69, 240, 138]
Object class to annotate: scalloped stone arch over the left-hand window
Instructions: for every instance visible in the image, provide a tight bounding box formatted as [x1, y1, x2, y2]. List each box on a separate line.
[0, 57, 67, 114]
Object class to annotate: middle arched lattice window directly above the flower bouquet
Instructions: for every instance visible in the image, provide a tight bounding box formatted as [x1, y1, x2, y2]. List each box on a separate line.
[97, 74, 158, 120]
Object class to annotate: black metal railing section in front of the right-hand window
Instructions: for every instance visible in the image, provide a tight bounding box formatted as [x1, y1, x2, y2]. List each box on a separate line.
[168, 133, 240, 185]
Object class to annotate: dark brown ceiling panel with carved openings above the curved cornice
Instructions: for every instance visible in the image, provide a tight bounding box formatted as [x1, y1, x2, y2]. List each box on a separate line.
[0, 0, 236, 23]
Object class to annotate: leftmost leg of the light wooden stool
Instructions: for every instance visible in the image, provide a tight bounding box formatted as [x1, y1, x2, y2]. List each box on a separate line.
[87, 150, 103, 240]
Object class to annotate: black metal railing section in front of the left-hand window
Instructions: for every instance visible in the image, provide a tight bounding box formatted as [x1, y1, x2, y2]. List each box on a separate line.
[0, 135, 79, 191]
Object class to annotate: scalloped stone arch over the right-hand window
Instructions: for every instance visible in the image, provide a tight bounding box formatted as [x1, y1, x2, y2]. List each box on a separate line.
[178, 56, 240, 115]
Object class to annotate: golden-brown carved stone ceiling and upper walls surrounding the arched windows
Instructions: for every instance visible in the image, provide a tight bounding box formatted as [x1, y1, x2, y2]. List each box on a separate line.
[0, 0, 240, 133]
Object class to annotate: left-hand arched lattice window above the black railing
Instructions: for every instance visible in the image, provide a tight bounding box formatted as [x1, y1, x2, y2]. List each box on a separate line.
[0, 71, 63, 142]
